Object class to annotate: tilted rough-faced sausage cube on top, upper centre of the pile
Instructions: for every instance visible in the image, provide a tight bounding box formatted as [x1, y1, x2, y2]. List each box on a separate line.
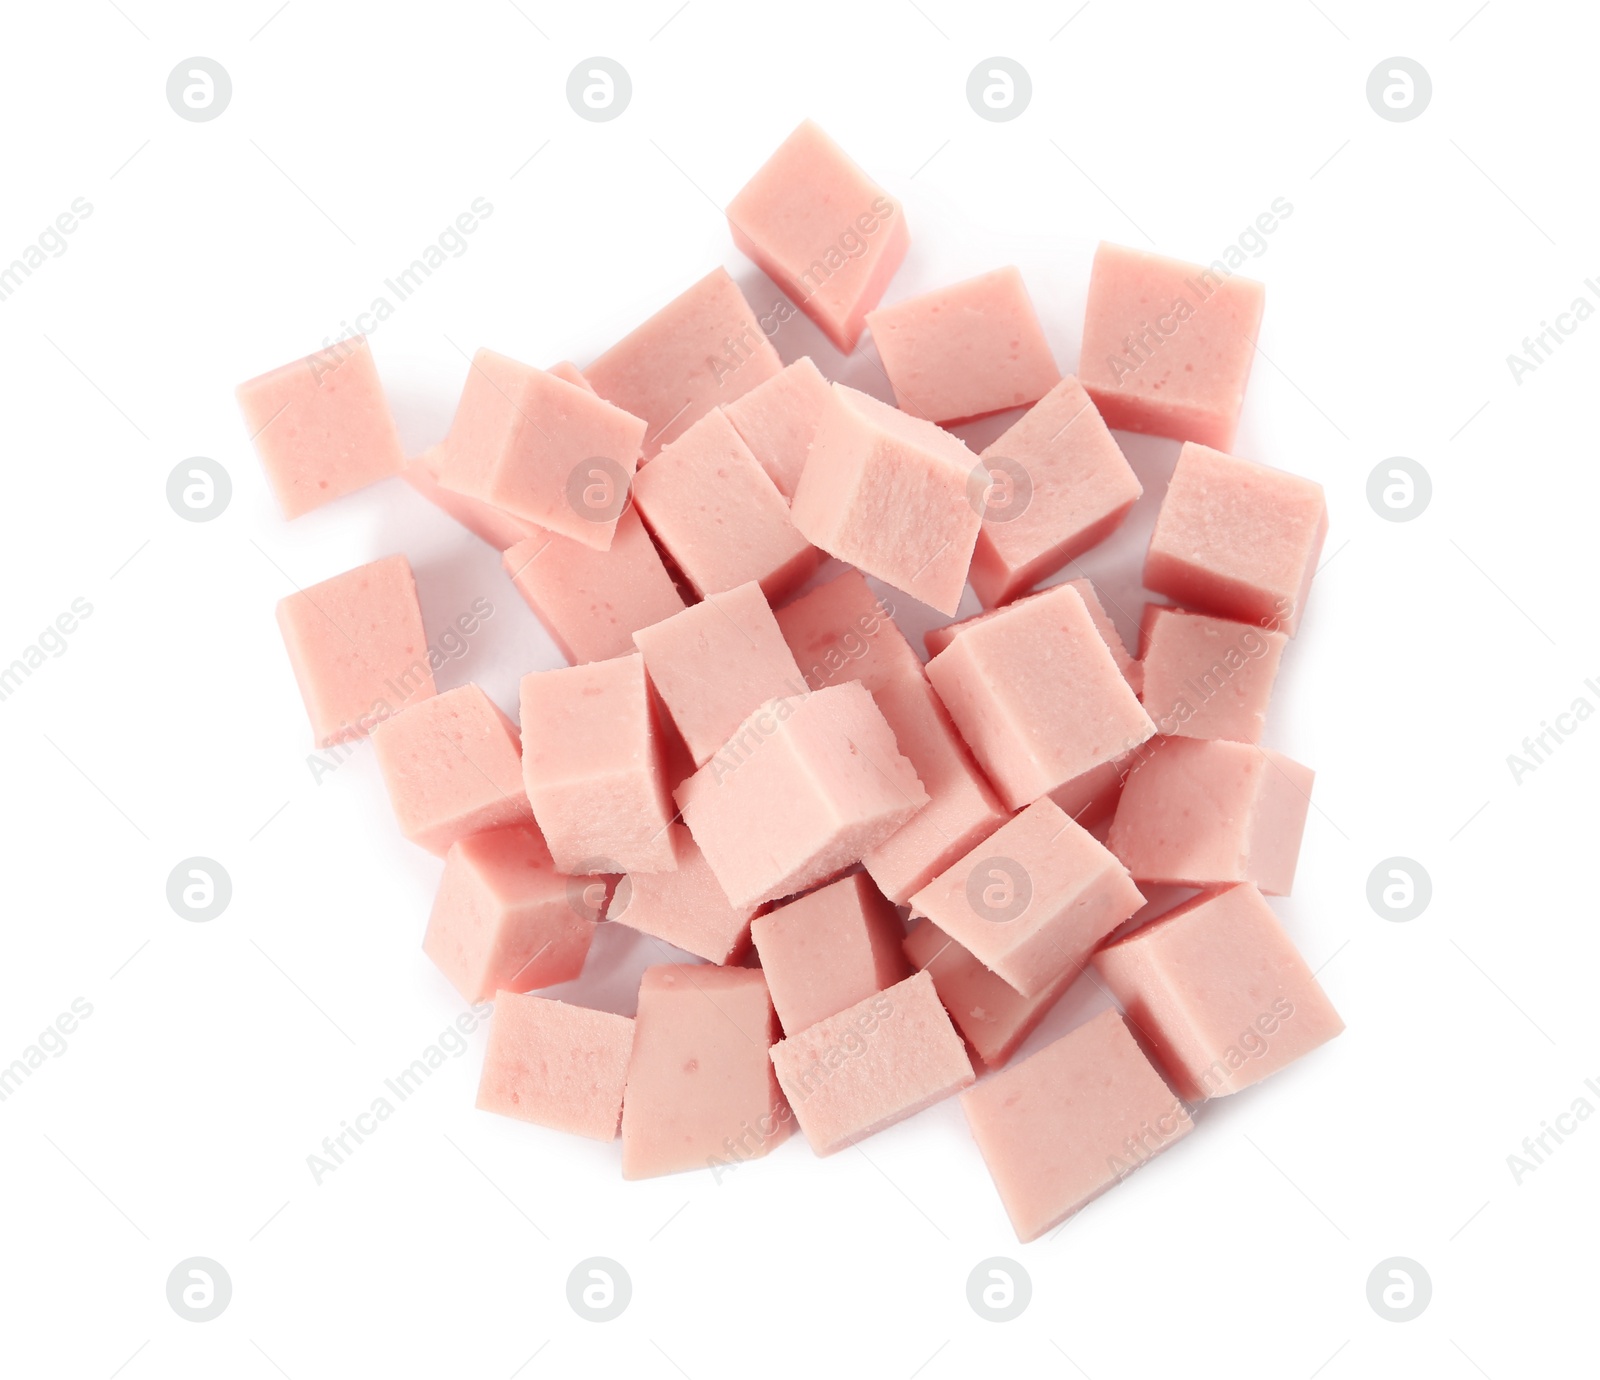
[790, 384, 981, 615]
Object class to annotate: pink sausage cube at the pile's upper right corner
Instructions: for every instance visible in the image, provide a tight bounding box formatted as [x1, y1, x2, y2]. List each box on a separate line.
[1078, 243, 1267, 448]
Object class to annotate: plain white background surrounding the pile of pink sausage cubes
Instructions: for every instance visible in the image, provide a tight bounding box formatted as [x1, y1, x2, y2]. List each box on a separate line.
[0, 0, 1600, 1380]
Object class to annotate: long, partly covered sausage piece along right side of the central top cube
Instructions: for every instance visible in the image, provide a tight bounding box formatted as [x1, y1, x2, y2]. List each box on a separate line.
[778, 570, 1006, 905]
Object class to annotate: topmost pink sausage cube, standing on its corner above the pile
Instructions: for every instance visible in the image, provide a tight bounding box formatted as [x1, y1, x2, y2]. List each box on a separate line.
[728, 120, 910, 354]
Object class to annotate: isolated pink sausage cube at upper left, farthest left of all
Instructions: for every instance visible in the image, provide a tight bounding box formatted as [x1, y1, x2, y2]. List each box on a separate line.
[237, 336, 405, 517]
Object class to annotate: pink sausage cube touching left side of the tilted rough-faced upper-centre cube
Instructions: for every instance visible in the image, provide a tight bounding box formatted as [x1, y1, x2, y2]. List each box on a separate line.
[634, 410, 822, 602]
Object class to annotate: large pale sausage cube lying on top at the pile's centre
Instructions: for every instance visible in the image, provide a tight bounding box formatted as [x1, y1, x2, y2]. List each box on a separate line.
[677, 682, 928, 906]
